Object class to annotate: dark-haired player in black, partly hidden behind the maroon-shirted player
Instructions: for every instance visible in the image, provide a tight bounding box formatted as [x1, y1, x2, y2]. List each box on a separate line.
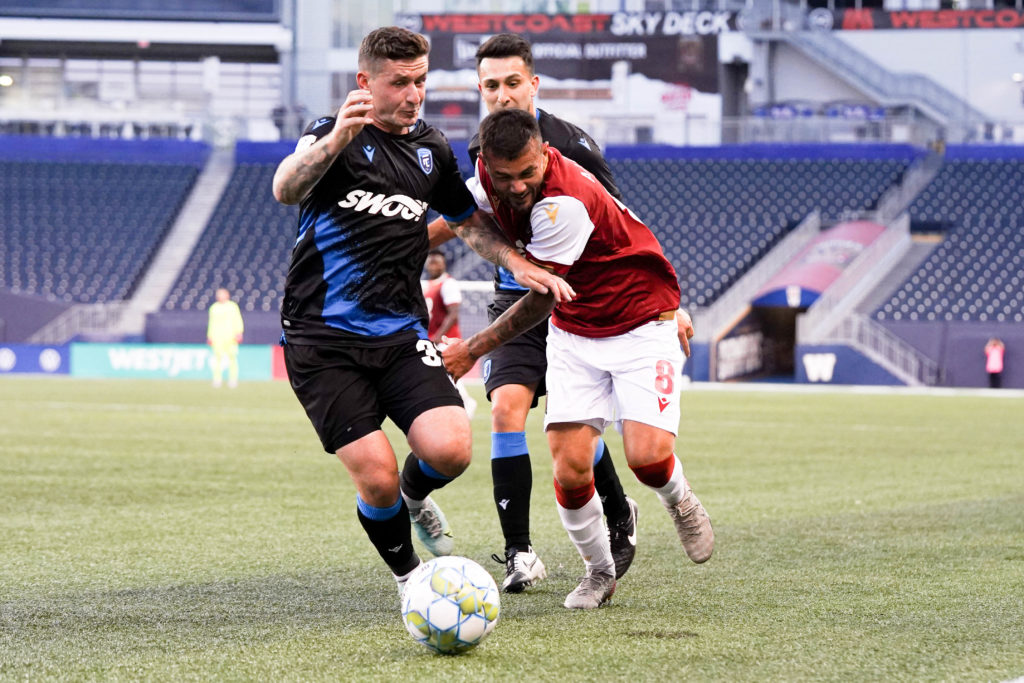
[430, 34, 693, 593]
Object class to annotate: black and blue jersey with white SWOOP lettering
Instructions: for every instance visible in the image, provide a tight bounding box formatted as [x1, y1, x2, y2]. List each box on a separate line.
[281, 117, 476, 346]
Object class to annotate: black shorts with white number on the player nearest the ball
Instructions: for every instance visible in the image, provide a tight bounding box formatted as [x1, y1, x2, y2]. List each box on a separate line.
[285, 339, 462, 453]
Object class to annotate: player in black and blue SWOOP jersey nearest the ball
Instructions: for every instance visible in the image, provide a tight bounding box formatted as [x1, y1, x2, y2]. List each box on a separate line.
[273, 27, 572, 591]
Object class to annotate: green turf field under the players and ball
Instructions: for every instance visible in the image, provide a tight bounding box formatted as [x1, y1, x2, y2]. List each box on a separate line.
[0, 378, 1024, 683]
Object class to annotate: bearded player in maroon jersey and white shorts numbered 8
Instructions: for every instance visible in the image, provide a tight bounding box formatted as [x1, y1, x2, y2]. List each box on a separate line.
[443, 109, 715, 609]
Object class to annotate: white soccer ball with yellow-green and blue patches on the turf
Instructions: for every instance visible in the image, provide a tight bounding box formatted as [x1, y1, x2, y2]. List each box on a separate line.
[401, 555, 501, 654]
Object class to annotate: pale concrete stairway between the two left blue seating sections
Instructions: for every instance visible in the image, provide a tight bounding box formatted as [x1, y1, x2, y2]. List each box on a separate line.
[112, 147, 234, 337]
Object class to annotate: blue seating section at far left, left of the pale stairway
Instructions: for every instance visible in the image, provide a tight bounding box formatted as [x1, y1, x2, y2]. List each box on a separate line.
[0, 160, 200, 303]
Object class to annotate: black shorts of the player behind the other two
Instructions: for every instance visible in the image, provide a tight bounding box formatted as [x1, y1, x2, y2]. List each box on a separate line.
[483, 294, 548, 408]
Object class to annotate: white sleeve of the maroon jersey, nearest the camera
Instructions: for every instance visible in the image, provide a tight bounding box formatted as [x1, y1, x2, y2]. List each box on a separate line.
[526, 197, 594, 274]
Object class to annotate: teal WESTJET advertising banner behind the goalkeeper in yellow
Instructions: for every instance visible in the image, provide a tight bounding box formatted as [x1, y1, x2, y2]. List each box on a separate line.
[71, 344, 271, 382]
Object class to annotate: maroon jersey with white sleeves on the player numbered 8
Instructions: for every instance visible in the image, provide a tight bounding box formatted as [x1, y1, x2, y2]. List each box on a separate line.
[471, 147, 679, 337]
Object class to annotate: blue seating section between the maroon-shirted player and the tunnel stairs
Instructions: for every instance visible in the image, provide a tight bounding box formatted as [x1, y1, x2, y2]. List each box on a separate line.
[450, 158, 907, 306]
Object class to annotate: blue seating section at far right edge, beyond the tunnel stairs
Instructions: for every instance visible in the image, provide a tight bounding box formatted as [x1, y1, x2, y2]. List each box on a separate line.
[874, 159, 1024, 323]
